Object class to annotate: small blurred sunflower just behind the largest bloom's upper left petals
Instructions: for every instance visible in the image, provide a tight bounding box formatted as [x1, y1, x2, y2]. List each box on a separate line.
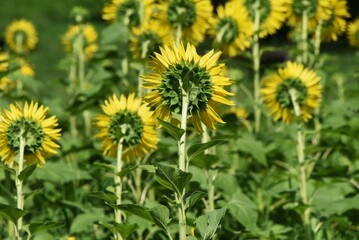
[131, 20, 174, 59]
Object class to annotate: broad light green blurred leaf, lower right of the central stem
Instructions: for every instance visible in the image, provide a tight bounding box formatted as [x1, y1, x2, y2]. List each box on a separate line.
[226, 190, 258, 233]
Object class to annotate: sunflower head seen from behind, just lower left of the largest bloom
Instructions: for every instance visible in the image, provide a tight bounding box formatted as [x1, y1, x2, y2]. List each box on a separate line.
[96, 93, 158, 161]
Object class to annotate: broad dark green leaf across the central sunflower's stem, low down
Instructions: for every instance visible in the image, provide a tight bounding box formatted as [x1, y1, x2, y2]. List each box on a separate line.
[156, 165, 192, 195]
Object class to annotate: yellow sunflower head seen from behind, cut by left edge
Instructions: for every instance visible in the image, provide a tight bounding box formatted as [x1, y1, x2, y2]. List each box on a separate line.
[0, 101, 61, 166]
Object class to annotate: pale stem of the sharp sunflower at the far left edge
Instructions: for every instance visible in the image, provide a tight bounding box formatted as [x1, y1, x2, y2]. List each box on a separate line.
[15, 128, 26, 240]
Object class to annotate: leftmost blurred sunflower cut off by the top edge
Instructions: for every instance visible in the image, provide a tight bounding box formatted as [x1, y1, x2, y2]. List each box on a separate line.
[102, 0, 154, 27]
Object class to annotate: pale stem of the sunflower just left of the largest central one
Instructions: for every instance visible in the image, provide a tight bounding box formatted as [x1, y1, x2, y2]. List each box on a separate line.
[114, 138, 124, 240]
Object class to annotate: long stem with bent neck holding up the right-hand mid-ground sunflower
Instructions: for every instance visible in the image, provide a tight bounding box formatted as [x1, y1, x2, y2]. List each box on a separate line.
[289, 89, 312, 240]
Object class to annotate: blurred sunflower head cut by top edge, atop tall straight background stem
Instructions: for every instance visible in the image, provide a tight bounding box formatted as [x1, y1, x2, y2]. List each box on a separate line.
[240, 0, 291, 38]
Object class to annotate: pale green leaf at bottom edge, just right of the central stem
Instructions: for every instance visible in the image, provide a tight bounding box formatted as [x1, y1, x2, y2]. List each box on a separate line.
[195, 208, 226, 240]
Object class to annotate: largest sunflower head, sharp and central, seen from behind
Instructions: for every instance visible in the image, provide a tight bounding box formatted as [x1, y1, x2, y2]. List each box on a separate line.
[142, 42, 234, 132]
